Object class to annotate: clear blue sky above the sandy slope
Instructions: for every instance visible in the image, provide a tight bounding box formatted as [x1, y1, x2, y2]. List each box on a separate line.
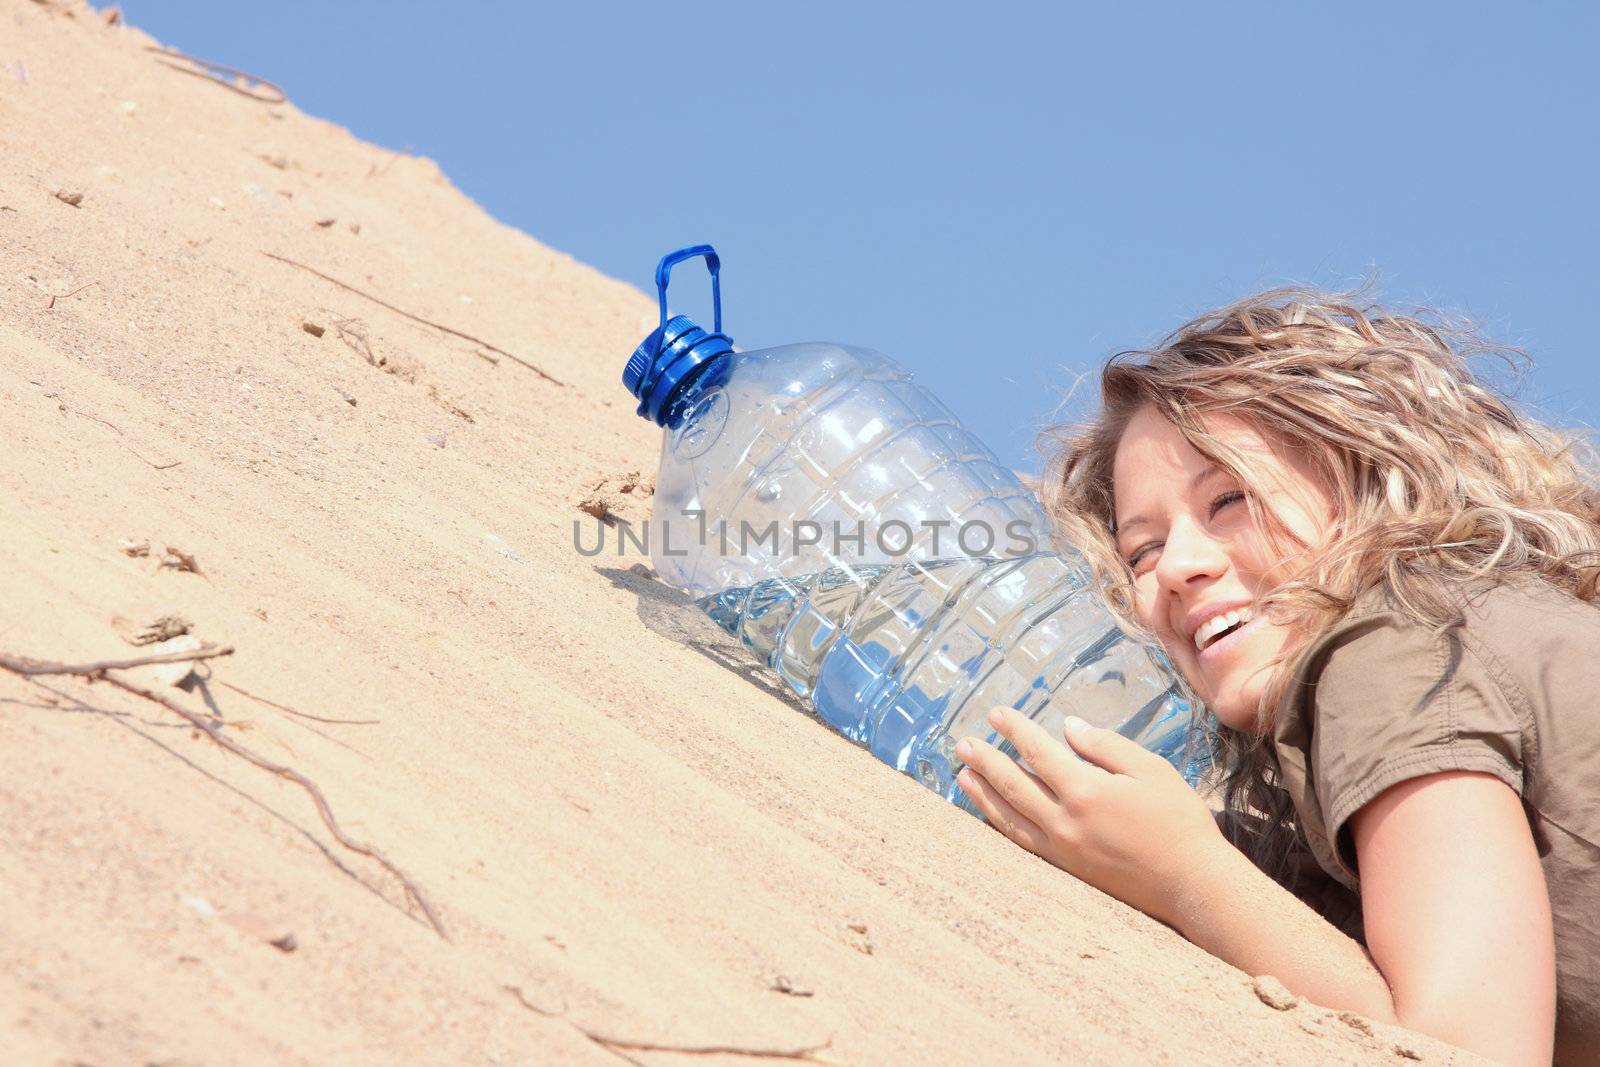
[123, 0, 1600, 469]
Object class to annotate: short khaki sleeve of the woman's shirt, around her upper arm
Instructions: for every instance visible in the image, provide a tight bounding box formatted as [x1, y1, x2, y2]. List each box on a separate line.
[1307, 613, 1528, 881]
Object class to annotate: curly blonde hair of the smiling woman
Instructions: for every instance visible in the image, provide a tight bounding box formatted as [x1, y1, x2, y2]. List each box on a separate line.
[1040, 290, 1600, 873]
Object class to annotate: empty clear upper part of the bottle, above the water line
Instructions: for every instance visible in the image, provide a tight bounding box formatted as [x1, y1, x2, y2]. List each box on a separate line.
[650, 344, 1050, 597]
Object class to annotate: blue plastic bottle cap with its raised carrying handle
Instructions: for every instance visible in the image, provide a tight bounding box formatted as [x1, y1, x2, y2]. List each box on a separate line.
[622, 245, 733, 429]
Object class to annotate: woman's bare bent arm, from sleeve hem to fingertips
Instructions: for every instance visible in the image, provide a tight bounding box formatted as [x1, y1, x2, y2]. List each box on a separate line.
[957, 710, 1555, 1064]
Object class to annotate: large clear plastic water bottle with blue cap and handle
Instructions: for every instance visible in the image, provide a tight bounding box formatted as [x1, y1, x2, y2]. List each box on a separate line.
[622, 245, 1200, 803]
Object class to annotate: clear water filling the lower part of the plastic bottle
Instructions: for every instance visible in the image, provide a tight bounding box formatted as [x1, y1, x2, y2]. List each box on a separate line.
[696, 553, 1200, 803]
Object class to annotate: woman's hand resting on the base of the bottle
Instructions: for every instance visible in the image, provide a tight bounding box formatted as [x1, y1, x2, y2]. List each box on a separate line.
[955, 707, 1232, 926]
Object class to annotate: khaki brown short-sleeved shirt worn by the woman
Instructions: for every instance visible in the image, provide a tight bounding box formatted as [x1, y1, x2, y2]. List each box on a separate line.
[1274, 579, 1600, 1064]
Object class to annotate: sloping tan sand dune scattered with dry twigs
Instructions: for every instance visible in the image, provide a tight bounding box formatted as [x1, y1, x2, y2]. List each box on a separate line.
[0, 0, 1472, 1065]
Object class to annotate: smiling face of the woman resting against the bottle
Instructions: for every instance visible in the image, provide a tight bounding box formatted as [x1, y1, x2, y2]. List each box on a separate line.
[1112, 405, 1334, 729]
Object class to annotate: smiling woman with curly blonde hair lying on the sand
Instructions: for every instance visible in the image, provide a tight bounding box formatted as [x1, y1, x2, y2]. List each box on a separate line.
[958, 291, 1600, 1064]
